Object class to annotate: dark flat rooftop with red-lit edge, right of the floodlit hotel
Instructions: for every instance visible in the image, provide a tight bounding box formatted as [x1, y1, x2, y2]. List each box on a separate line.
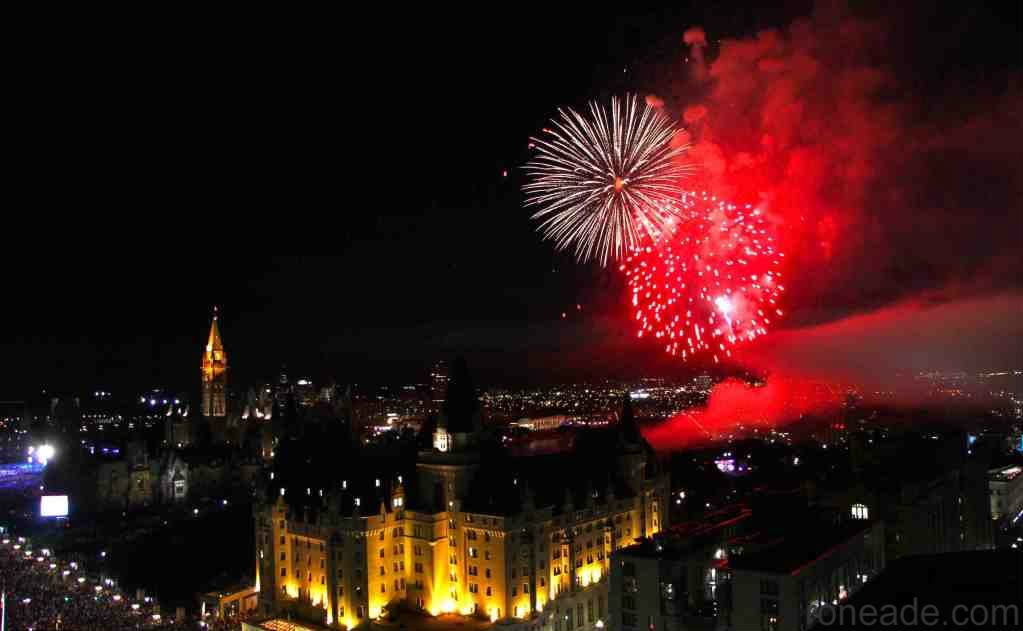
[728, 520, 875, 575]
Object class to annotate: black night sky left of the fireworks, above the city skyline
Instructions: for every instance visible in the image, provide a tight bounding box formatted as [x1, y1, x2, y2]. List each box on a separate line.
[0, 2, 1020, 398]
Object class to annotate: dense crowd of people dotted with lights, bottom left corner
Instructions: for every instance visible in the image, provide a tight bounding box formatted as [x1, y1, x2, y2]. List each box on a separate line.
[0, 534, 199, 631]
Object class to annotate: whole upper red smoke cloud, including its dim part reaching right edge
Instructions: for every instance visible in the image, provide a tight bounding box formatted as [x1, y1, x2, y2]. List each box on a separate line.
[676, 3, 1023, 323]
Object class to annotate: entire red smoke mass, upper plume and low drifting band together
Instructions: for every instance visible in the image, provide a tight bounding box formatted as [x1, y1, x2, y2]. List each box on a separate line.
[648, 3, 1023, 449]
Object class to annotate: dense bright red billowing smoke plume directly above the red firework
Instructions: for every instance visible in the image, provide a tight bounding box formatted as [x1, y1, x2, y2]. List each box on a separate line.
[685, 11, 900, 292]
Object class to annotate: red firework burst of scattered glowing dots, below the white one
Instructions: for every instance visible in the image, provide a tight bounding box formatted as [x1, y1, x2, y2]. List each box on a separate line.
[619, 192, 785, 362]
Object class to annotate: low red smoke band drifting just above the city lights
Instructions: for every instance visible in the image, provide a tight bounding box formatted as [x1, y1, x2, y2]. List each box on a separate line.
[644, 294, 1023, 450]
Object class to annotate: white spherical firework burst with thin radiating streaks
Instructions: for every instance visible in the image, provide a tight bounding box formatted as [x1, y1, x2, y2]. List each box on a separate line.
[523, 96, 688, 265]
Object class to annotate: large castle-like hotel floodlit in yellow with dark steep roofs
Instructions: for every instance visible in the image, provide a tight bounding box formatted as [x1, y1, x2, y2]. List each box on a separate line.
[255, 400, 668, 631]
